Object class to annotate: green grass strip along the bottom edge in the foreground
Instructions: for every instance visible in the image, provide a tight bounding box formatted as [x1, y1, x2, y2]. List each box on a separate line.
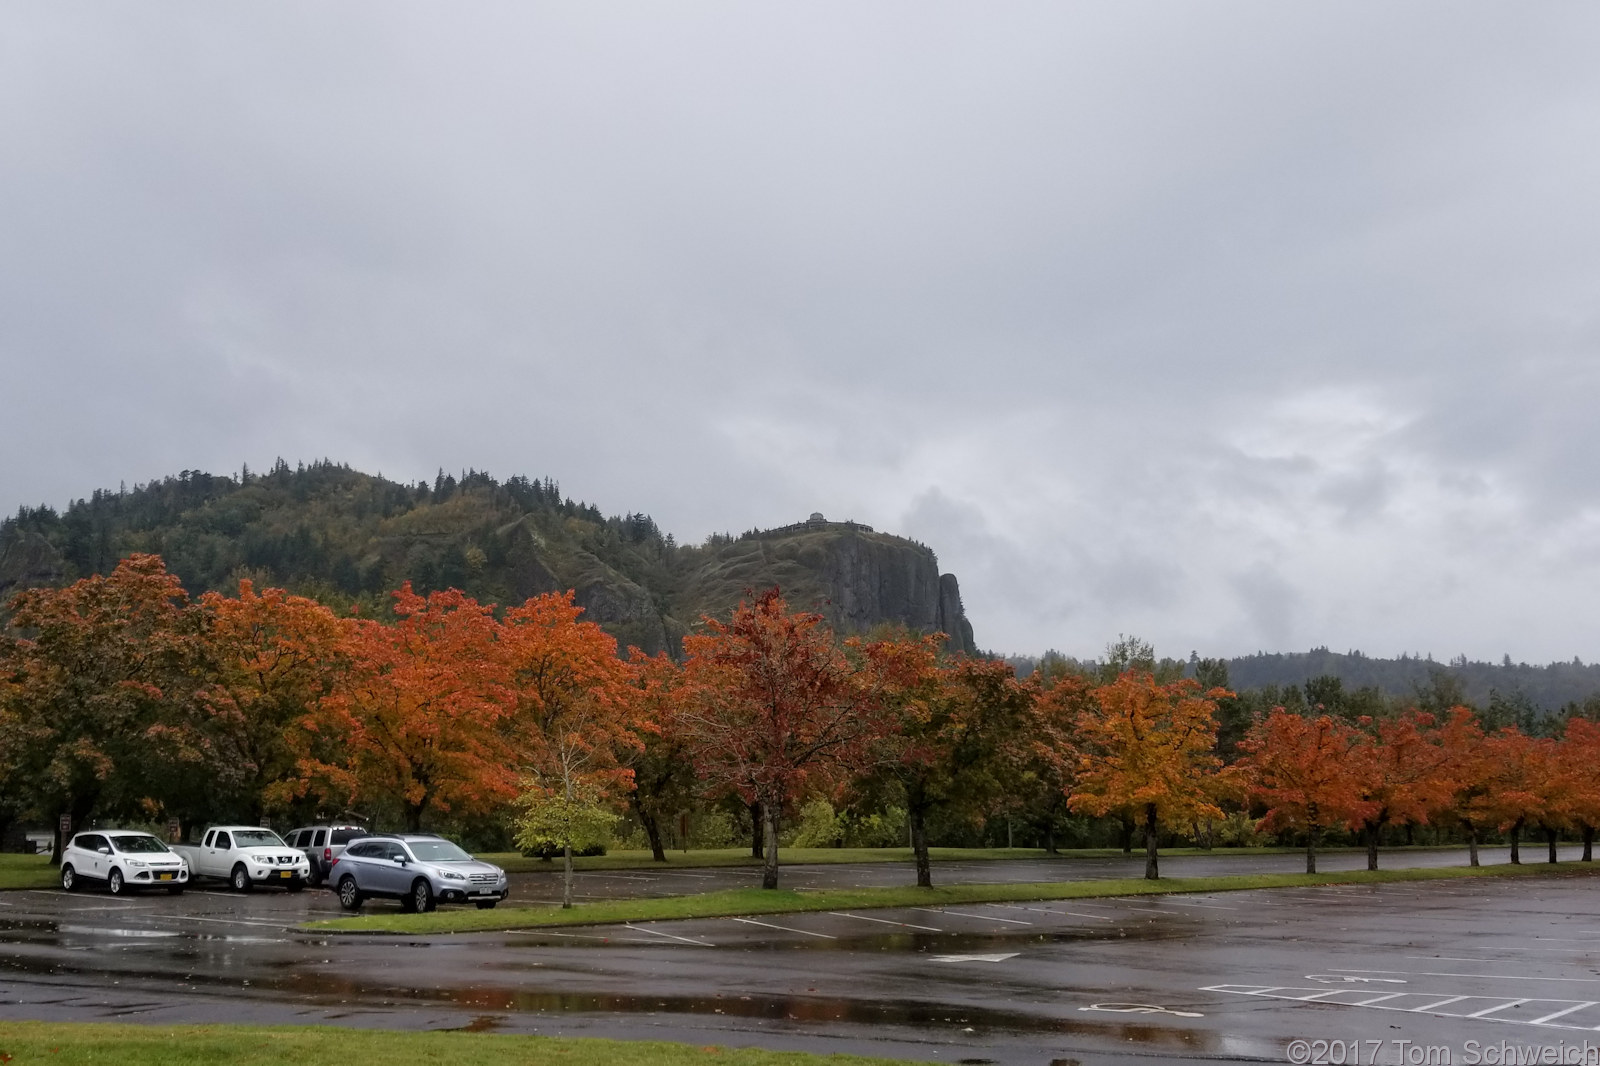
[0, 1021, 908, 1066]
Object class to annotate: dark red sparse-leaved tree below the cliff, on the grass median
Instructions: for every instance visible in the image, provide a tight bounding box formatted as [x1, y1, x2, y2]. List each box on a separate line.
[678, 589, 890, 888]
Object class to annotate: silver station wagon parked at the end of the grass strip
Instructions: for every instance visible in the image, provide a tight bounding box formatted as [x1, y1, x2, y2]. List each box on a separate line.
[328, 834, 510, 911]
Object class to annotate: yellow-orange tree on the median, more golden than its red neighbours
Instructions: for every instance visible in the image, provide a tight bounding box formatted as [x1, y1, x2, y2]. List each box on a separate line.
[1069, 671, 1229, 880]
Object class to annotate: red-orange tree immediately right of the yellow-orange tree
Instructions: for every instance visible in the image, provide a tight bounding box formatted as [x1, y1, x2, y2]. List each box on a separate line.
[1235, 707, 1366, 874]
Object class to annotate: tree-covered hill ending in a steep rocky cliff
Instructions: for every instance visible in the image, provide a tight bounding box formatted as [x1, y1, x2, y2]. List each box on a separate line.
[0, 459, 974, 653]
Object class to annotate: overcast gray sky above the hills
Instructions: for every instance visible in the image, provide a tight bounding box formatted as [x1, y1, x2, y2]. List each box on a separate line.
[0, 0, 1600, 661]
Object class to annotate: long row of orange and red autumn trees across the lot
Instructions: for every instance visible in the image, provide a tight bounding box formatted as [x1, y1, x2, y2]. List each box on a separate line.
[0, 555, 1600, 903]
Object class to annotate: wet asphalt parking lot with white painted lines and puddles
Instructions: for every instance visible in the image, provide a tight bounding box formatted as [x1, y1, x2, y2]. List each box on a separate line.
[0, 848, 1600, 1066]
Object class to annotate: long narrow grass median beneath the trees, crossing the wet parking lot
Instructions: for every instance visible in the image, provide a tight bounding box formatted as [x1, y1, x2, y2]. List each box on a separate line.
[302, 863, 1597, 933]
